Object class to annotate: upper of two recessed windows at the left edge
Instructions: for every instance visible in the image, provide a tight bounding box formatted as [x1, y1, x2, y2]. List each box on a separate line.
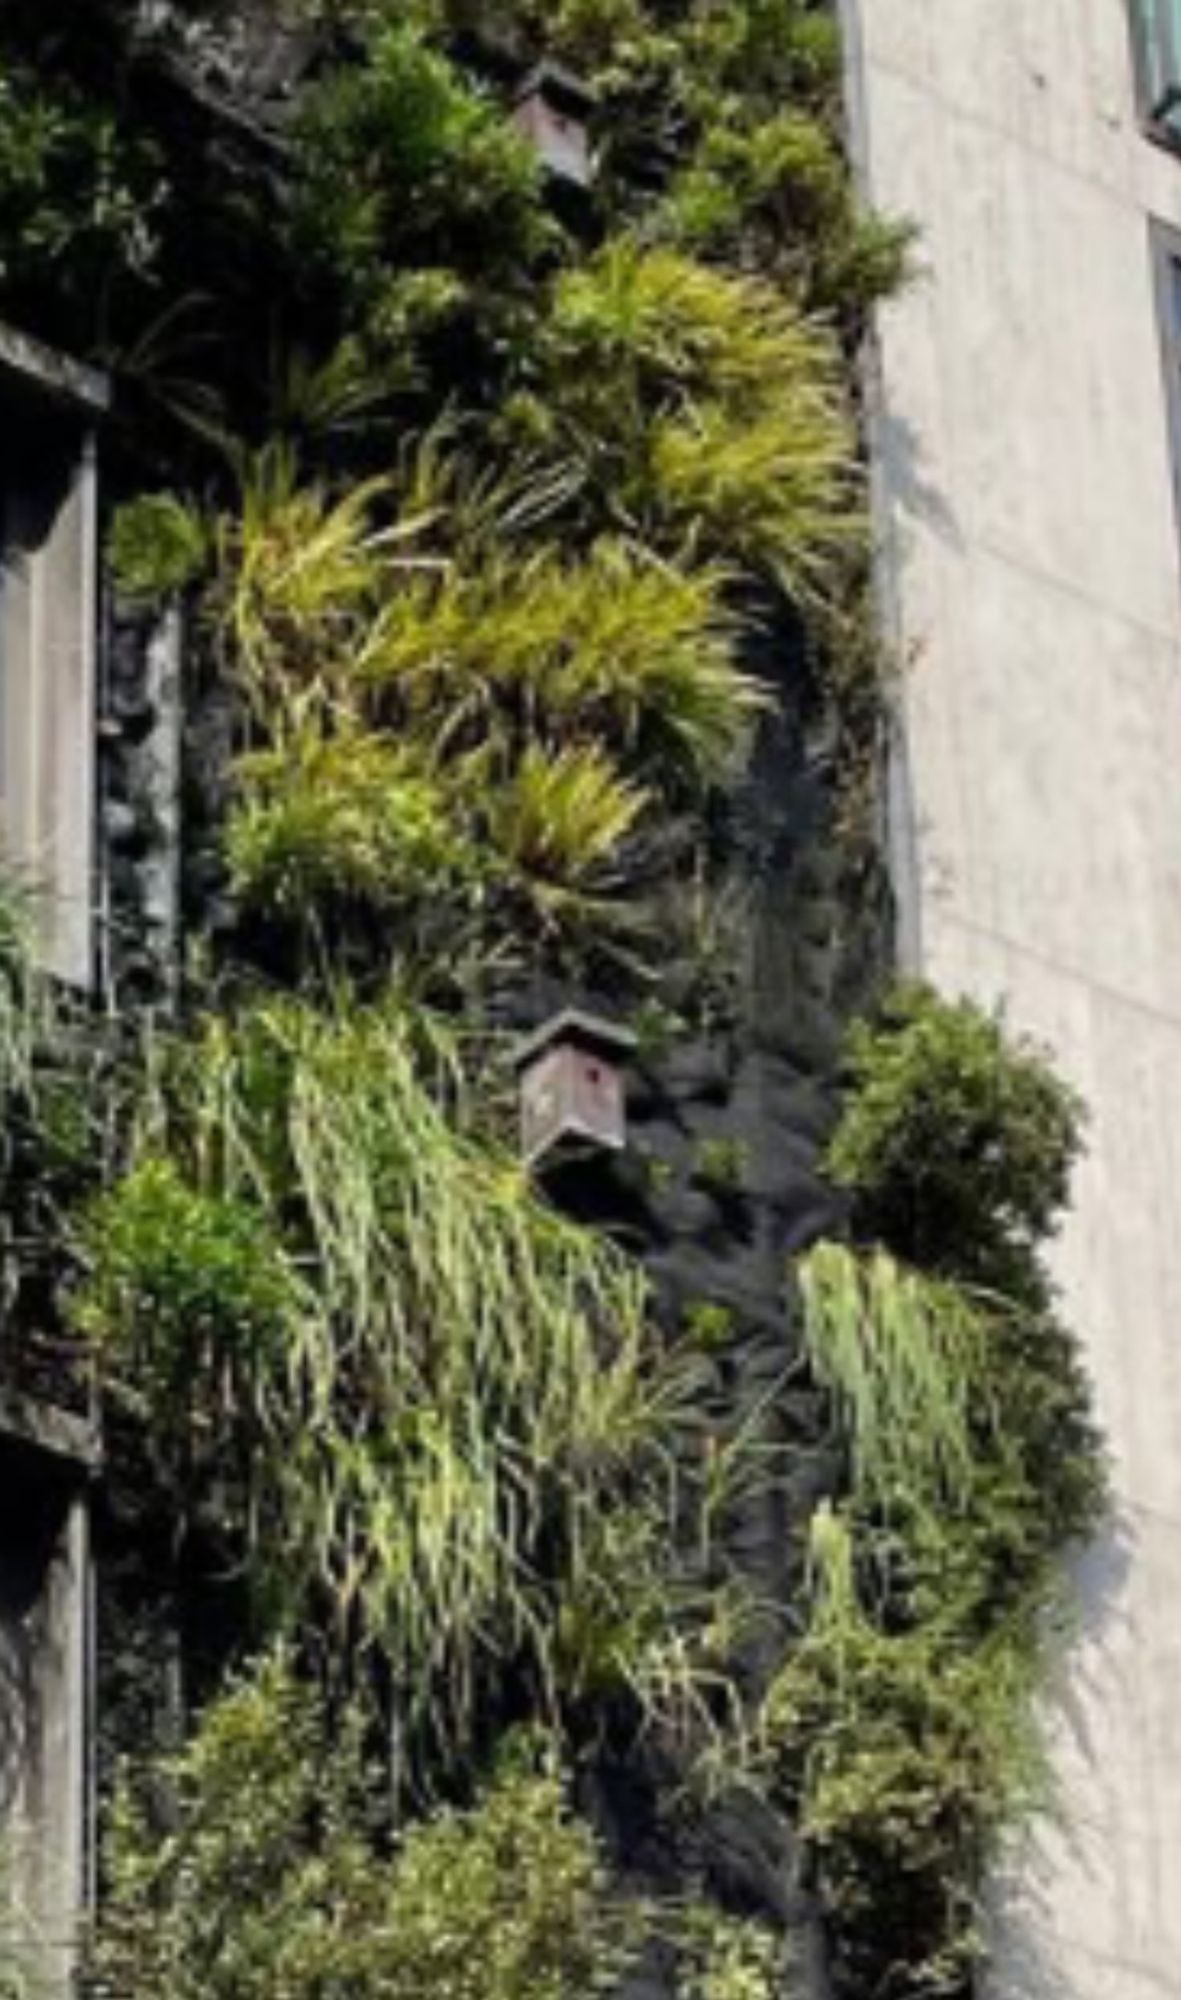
[0, 328, 104, 986]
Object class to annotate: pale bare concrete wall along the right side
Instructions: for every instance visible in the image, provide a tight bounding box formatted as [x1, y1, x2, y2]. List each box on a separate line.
[845, 0, 1181, 2000]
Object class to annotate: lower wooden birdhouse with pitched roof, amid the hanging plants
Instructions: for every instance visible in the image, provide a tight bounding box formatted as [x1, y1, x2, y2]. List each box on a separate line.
[514, 1008, 637, 1166]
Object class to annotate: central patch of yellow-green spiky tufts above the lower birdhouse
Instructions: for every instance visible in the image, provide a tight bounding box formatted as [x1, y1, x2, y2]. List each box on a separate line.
[210, 456, 765, 942]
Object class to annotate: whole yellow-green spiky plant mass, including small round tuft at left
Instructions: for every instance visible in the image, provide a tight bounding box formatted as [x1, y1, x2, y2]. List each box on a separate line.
[112, 236, 859, 964]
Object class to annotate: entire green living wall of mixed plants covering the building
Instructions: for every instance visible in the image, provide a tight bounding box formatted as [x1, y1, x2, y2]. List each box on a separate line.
[0, 0, 1103, 2000]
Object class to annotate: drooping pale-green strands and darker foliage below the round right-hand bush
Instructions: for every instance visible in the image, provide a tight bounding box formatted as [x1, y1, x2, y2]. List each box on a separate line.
[801, 1244, 1105, 1632]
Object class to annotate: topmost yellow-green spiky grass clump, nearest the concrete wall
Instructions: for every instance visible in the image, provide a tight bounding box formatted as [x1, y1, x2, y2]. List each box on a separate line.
[538, 238, 861, 596]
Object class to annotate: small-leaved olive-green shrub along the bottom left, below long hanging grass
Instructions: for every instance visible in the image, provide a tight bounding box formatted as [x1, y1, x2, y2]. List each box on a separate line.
[94, 1658, 637, 2000]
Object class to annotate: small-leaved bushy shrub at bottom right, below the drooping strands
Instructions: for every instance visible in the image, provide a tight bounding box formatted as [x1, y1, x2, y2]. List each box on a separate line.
[765, 1516, 1047, 1996]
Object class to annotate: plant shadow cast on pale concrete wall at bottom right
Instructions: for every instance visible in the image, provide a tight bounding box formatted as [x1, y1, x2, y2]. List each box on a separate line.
[981, 1516, 1144, 2000]
